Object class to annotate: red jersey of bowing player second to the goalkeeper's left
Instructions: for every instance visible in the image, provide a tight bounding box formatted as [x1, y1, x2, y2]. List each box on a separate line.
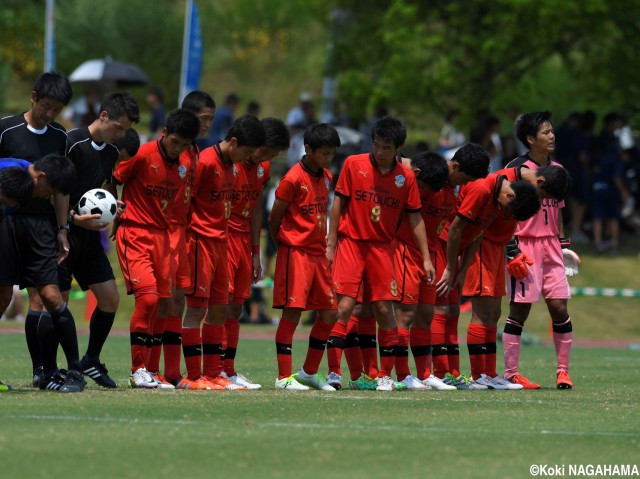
[440, 173, 506, 251]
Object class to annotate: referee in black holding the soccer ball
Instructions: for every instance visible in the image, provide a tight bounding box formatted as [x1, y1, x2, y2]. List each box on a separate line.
[58, 93, 140, 388]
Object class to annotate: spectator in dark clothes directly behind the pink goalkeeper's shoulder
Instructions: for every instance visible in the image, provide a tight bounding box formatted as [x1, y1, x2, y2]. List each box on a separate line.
[555, 112, 591, 244]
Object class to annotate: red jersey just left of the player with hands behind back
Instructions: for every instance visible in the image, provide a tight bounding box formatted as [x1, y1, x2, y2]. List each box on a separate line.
[229, 161, 271, 233]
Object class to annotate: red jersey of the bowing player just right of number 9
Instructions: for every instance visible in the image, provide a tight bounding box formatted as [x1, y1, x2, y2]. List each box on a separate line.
[397, 185, 457, 251]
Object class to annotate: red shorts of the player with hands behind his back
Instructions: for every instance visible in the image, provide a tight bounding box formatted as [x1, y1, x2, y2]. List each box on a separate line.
[273, 245, 337, 310]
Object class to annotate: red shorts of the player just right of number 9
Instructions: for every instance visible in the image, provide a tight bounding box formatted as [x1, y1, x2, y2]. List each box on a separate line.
[394, 241, 436, 305]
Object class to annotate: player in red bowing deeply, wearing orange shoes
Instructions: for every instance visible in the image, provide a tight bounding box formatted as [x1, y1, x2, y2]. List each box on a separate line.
[177, 115, 266, 389]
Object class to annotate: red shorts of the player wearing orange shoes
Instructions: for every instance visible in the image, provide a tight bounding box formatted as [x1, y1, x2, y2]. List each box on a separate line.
[187, 231, 229, 308]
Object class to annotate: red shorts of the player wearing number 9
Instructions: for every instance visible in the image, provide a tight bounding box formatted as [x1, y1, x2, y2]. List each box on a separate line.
[333, 236, 398, 301]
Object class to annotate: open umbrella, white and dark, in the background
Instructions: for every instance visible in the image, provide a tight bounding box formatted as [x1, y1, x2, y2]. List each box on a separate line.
[69, 59, 149, 88]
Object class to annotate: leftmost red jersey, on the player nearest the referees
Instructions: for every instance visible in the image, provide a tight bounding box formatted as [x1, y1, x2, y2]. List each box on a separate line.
[113, 140, 184, 229]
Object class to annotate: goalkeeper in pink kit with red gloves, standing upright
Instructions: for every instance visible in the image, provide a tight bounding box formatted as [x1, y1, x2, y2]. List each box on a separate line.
[503, 111, 575, 389]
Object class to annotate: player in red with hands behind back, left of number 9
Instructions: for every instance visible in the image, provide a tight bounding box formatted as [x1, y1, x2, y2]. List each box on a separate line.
[269, 123, 340, 391]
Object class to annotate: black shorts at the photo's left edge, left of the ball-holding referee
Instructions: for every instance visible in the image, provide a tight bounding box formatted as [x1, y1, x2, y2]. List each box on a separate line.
[0, 214, 58, 288]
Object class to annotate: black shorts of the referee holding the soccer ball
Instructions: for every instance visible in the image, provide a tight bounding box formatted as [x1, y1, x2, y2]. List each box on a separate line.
[58, 225, 115, 291]
